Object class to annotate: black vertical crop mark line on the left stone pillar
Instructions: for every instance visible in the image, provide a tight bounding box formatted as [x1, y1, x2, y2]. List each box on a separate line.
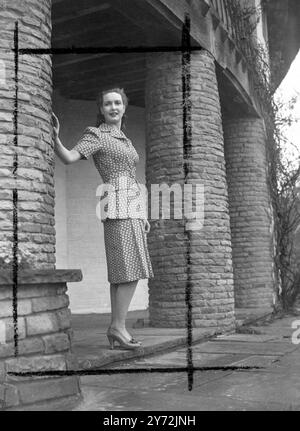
[12, 21, 19, 356]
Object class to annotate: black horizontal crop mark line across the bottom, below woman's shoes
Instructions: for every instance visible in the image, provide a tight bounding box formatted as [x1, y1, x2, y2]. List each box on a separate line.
[7, 365, 264, 377]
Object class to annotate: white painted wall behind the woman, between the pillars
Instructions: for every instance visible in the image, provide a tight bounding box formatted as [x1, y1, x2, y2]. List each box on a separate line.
[53, 91, 148, 313]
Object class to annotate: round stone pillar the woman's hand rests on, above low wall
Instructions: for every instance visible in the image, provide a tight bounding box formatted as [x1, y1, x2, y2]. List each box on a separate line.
[0, 0, 55, 268]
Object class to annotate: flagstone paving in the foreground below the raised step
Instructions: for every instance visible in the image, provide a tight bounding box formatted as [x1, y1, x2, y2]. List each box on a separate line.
[74, 340, 300, 411]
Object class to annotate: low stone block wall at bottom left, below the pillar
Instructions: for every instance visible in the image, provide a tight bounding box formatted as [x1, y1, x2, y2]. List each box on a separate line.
[0, 271, 80, 409]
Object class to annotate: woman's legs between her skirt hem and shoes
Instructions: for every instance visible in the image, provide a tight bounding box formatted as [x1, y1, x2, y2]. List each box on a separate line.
[111, 280, 138, 339]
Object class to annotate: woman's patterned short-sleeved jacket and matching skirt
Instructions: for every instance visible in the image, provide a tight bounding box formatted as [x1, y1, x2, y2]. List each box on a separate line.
[73, 123, 154, 283]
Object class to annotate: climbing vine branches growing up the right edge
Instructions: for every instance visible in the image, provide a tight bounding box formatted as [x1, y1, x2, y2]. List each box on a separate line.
[225, 0, 300, 309]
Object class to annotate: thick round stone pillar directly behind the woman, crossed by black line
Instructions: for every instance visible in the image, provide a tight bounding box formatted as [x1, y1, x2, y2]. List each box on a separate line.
[146, 50, 234, 331]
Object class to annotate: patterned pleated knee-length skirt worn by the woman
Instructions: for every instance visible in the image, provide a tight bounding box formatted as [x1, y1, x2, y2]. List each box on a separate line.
[103, 218, 154, 283]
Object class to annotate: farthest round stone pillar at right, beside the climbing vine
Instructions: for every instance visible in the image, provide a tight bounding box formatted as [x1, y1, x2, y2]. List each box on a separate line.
[223, 118, 275, 308]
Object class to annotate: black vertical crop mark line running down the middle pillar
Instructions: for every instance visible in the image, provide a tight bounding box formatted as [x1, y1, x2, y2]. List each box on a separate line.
[181, 14, 194, 391]
